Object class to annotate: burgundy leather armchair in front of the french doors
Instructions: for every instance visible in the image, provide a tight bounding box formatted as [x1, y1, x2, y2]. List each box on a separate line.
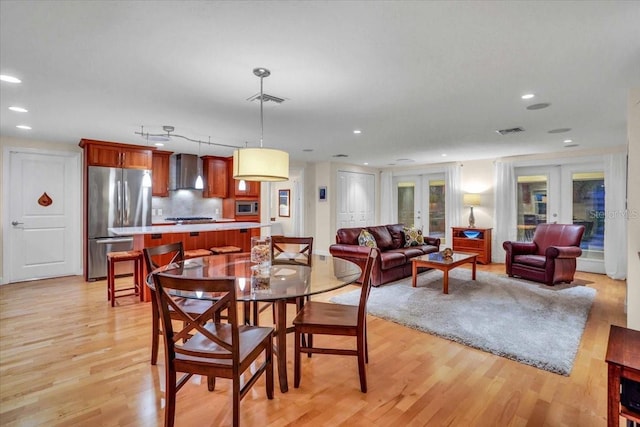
[502, 224, 584, 285]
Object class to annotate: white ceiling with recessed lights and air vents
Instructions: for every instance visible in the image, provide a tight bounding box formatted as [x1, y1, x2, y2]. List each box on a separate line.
[0, 0, 640, 167]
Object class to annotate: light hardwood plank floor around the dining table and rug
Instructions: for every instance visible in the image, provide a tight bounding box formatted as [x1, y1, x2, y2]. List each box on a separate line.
[0, 264, 626, 426]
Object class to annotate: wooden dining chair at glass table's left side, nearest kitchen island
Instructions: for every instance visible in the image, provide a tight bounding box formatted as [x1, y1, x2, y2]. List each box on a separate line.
[142, 242, 220, 365]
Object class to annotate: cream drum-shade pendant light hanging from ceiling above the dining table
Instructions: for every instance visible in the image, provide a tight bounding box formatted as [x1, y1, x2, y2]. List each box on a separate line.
[233, 68, 289, 181]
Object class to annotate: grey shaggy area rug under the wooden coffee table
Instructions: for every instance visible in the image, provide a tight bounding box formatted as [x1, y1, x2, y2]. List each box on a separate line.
[331, 268, 596, 375]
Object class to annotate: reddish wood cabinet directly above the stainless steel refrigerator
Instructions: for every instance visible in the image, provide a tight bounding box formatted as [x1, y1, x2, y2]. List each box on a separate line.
[80, 139, 153, 170]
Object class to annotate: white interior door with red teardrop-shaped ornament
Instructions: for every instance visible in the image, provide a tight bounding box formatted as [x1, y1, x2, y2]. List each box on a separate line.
[3, 149, 82, 283]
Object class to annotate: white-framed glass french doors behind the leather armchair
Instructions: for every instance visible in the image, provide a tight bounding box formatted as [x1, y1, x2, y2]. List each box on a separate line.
[516, 164, 605, 273]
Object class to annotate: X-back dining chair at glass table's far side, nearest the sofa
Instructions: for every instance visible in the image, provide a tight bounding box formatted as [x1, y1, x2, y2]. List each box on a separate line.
[253, 235, 313, 326]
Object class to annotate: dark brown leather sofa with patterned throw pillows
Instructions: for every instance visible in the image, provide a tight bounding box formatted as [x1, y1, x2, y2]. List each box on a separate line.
[329, 224, 440, 286]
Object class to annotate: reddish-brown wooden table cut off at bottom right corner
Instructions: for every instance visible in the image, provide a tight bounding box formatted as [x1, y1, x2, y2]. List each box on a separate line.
[605, 325, 640, 427]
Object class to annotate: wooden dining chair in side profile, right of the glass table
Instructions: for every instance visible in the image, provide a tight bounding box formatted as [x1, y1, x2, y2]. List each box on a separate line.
[293, 248, 378, 393]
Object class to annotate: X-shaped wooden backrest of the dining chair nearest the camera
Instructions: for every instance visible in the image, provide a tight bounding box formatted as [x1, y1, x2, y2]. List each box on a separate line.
[153, 272, 240, 365]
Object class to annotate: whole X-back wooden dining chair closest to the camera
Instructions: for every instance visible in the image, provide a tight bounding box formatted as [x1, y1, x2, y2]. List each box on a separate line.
[153, 272, 274, 427]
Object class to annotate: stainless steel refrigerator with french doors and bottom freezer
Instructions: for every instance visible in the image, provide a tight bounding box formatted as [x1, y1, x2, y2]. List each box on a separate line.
[87, 166, 151, 280]
